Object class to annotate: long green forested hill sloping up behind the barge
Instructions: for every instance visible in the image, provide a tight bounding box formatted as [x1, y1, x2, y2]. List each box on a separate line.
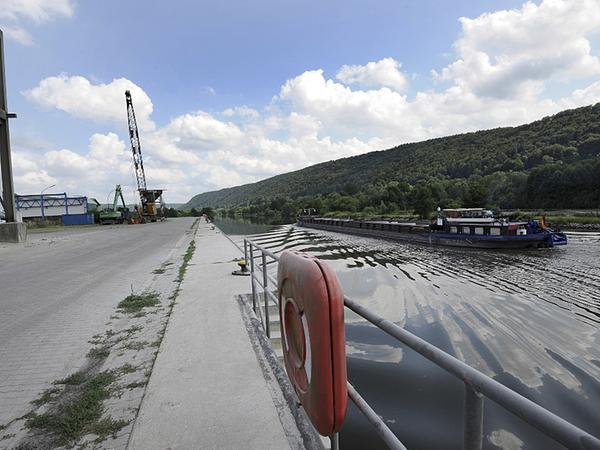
[184, 103, 600, 211]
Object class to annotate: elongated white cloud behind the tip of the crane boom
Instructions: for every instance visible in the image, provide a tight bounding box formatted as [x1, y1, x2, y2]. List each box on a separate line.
[23, 74, 154, 131]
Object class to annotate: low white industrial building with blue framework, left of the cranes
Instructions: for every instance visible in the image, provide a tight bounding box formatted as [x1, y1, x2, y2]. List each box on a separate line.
[15, 192, 94, 225]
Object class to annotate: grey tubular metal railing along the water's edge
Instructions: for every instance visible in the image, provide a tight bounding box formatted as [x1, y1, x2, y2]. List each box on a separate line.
[244, 239, 600, 450]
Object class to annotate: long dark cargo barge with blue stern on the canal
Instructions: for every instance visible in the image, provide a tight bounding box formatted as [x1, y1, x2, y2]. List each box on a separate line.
[298, 208, 567, 249]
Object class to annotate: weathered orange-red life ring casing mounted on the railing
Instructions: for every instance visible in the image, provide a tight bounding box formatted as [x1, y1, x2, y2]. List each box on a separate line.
[277, 251, 348, 436]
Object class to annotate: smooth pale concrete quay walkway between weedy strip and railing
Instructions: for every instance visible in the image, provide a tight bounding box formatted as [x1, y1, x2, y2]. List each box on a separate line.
[128, 222, 312, 450]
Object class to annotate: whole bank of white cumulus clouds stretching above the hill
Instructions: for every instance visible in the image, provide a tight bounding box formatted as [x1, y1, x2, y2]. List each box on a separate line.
[14, 0, 600, 202]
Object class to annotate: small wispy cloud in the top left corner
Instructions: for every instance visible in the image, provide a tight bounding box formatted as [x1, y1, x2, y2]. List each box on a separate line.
[0, 0, 74, 45]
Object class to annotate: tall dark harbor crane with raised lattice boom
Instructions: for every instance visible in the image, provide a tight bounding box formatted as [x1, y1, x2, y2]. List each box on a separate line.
[125, 91, 163, 222]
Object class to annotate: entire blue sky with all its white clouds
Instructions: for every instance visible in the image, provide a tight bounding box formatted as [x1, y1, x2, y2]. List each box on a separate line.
[0, 0, 600, 203]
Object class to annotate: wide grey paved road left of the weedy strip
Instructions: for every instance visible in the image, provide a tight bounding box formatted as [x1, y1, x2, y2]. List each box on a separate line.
[0, 218, 193, 425]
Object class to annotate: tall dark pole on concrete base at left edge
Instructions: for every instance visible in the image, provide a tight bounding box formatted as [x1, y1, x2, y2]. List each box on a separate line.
[0, 30, 27, 242]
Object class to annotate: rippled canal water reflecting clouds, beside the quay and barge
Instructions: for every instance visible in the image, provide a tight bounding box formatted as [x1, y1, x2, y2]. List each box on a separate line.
[219, 219, 600, 449]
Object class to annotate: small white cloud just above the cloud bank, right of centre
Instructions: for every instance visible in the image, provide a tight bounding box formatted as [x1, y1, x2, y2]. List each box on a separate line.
[336, 58, 408, 92]
